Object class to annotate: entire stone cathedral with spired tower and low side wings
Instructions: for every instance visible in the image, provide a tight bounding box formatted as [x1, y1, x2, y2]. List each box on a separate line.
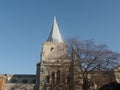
[0, 17, 120, 90]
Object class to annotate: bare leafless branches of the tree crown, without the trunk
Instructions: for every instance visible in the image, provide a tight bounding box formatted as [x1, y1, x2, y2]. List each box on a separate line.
[67, 39, 120, 71]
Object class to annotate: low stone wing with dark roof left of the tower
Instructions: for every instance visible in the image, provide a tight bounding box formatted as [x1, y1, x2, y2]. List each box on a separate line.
[0, 74, 36, 90]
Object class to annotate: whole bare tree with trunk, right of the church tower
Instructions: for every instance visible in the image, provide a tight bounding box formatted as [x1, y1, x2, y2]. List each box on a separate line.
[67, 39, 120, 90]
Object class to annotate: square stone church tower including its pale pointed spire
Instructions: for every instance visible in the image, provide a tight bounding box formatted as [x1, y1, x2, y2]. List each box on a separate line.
[35, 17, 70, 90]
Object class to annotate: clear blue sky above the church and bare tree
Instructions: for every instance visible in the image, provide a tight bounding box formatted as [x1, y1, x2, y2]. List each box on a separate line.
[0, 0, 120, 74]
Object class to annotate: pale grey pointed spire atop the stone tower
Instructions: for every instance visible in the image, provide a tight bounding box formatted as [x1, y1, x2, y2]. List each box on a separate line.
[47, 16, 63, 42]
